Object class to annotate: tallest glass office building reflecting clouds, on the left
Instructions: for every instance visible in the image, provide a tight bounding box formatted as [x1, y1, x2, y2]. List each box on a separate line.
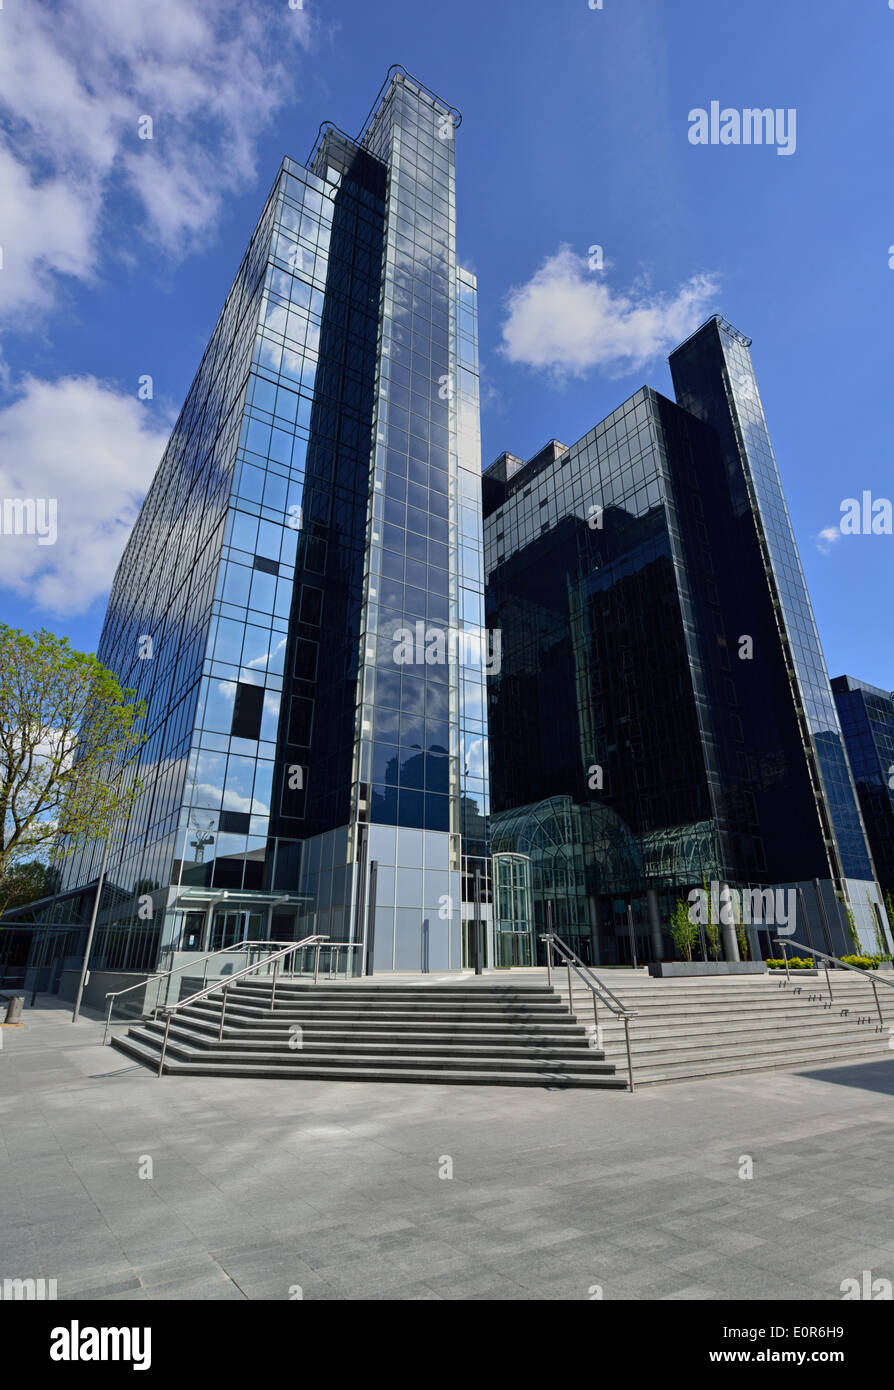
[47, 68, 488, 972]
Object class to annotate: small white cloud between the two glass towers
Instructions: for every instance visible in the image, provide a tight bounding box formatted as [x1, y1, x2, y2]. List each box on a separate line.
[502, 246, 717, 377]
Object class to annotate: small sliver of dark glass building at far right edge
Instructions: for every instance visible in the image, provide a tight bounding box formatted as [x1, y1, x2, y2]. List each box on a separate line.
[831, 676, 894, 898]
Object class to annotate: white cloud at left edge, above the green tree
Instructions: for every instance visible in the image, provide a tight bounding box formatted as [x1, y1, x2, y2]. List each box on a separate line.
[0, 377, 168, 614]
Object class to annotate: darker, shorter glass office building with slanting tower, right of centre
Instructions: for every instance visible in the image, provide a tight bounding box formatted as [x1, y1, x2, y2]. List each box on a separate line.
[482, 318, 879, 963]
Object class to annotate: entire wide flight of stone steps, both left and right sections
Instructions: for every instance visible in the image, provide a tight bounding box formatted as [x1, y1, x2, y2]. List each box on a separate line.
[114, 972, 894, 1090]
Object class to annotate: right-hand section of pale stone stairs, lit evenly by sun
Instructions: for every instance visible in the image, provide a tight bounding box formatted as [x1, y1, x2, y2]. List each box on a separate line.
[553, 970, 894, 1086]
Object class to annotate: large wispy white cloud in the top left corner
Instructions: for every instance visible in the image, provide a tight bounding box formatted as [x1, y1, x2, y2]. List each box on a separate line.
[0, 0, 310, 317]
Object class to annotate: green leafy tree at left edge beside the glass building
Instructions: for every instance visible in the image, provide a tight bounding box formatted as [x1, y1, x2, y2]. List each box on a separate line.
[0, 623, 146, 881]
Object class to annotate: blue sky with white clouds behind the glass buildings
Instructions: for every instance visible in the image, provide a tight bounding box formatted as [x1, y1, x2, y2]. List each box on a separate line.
[0, 0, 894, 689]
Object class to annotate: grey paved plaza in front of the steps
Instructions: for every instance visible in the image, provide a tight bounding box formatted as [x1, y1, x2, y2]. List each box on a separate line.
[0, 997, 894, 1300]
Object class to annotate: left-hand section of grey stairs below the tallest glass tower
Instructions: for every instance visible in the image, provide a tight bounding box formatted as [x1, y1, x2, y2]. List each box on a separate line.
[111, 976, 627, 1088]
